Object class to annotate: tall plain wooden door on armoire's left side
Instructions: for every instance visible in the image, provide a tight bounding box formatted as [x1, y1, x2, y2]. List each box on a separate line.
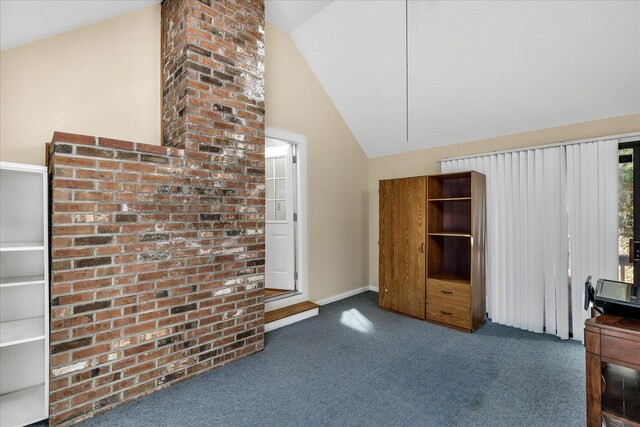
[378, 177, 426, 319]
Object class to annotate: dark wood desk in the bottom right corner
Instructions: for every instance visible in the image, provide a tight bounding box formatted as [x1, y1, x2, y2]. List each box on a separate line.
[584, 314, 640, 427]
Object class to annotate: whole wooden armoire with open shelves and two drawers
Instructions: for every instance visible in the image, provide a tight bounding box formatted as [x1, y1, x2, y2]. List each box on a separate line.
[379, 171, 486, 332]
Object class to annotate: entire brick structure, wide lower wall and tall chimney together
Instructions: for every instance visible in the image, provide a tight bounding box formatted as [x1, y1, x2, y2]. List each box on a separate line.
[50, 0, 264, 425]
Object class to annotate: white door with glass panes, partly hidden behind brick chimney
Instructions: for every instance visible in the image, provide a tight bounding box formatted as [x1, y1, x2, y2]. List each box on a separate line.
[265, 142, 296, 291]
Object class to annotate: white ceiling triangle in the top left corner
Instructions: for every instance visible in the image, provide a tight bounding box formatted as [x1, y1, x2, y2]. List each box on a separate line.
[0, 0, 161, 50]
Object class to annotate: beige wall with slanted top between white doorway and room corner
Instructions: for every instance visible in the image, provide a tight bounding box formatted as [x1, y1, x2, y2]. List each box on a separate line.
[265, 25, 369, 301]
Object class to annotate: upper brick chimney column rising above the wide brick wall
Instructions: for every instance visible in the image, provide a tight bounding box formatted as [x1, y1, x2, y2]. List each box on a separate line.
[162, 0, 264, 155]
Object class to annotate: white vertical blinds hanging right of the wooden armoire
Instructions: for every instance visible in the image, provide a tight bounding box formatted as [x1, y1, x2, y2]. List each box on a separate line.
[440, 140, 618, 340]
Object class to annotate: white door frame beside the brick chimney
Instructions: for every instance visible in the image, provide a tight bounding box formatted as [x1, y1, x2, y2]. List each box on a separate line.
[265, 127, 309, 311]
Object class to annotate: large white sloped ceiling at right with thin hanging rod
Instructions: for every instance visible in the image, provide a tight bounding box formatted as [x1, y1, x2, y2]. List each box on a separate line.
[267, 0, 640, 157]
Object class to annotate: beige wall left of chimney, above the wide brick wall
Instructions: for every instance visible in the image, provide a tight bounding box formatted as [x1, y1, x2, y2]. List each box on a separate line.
[0, 5, 160, 165]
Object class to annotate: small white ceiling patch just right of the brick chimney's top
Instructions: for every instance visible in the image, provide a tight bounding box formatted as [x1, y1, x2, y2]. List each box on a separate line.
[265, 0, 333, 33]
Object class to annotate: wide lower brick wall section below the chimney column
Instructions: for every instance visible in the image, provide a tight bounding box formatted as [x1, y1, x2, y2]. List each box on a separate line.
[50, 133, 264, 424]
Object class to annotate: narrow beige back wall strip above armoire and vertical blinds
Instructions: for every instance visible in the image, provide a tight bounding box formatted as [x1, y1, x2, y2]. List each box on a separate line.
[369, 114, 640, 287]
